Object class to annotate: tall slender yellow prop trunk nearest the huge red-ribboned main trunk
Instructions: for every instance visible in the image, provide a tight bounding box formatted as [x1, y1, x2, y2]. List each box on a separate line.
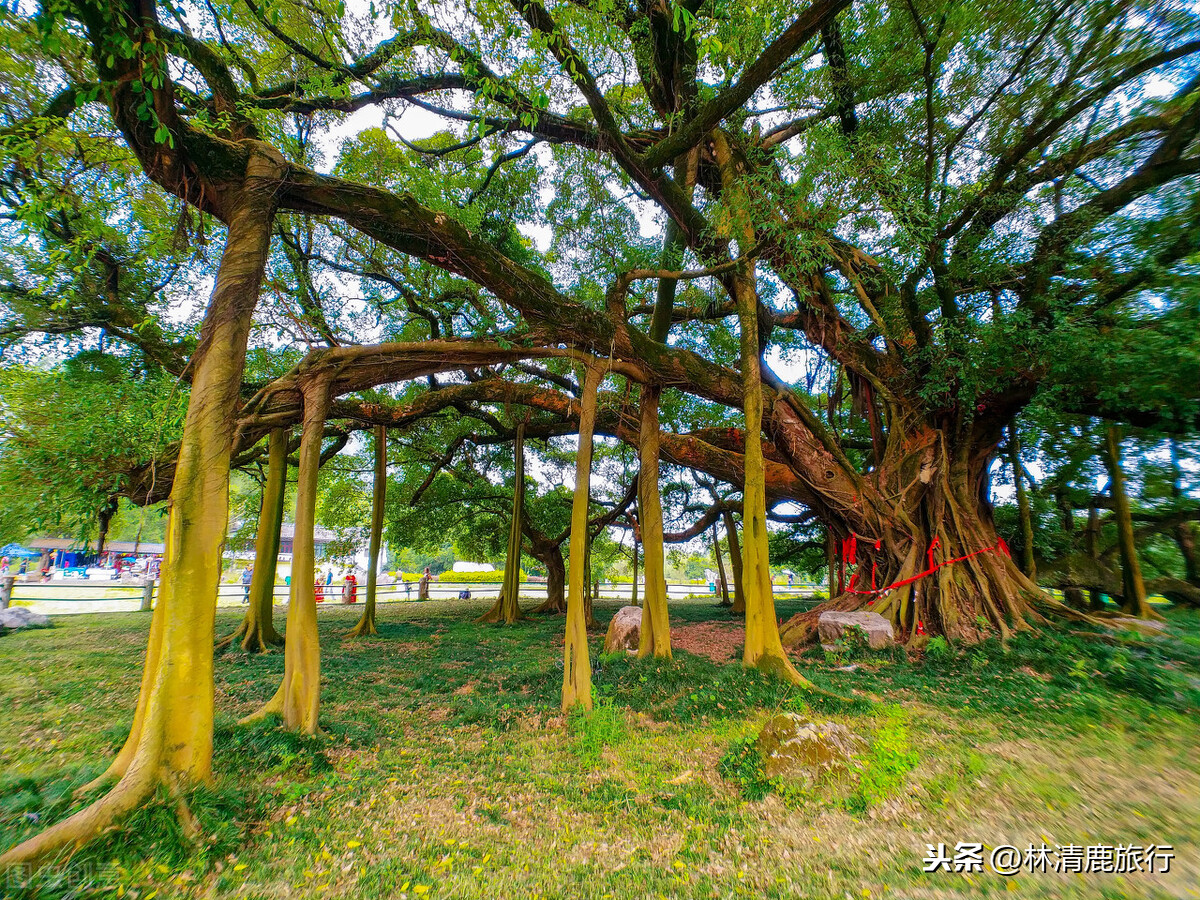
[713, 131, 808, 684]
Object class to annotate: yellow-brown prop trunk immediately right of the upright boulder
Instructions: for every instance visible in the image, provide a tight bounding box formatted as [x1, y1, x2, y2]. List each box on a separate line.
[637, 385, 671, 659]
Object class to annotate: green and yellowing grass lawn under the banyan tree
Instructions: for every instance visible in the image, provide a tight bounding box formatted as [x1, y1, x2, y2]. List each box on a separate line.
[0, 600, 1200, 900]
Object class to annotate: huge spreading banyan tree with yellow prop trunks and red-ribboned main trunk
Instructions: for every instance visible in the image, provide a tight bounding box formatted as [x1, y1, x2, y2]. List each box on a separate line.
[4, 0, 1200, 862]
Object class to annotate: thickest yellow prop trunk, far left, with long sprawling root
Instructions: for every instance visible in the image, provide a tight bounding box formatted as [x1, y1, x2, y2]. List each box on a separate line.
[0, 150, 281, 866]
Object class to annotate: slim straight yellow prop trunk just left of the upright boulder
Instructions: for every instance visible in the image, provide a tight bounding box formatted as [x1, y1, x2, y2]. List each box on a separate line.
[563, 364, 604, 713]
